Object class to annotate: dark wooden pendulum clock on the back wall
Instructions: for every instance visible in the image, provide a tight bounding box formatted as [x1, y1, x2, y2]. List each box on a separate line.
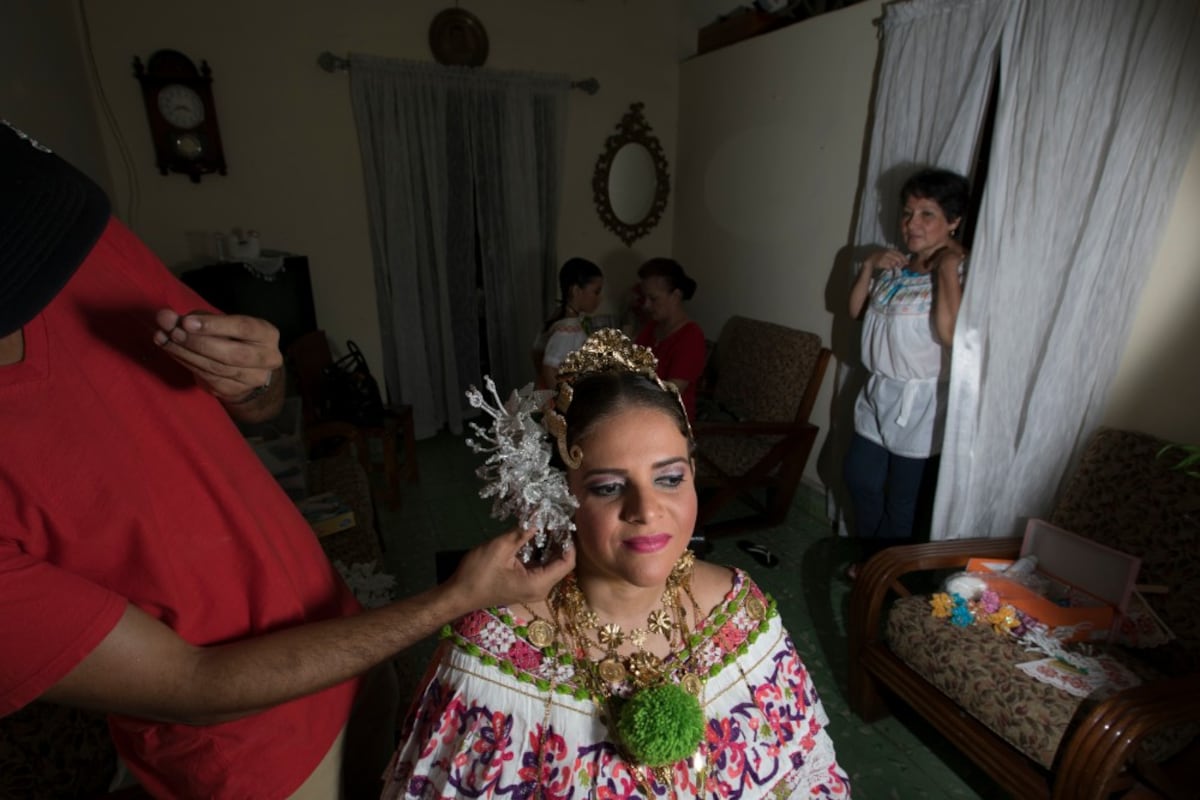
[133, 50, 226, 184]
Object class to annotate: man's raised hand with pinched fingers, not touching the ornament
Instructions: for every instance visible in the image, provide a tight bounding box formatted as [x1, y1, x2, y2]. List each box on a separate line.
[154, 308, 283, 403]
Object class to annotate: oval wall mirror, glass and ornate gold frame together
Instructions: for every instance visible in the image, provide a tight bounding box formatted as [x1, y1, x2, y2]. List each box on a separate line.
[592, 103, 671, 247]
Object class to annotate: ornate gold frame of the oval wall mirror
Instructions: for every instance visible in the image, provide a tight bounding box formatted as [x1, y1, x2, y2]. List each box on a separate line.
[592, 103, 671, 247]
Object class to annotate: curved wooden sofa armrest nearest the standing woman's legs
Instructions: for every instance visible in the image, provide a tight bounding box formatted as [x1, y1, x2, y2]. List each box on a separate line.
[848, 539, 1021, 663]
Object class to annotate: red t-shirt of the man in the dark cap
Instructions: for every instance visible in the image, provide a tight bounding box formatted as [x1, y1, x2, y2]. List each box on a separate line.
[0, 221, 359, 798]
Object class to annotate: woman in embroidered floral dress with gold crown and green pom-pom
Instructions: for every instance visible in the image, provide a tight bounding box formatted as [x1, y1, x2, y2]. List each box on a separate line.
[383, 329, 850, 800]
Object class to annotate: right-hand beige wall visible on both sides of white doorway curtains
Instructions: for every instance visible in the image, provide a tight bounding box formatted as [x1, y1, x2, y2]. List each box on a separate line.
[674, 1, 1200, 482]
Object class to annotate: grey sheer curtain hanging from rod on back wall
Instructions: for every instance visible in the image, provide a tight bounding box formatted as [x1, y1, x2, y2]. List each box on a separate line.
[350, 54, 569, 437]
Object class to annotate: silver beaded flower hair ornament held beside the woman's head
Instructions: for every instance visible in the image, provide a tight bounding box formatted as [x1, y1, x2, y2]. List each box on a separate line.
[467, 375, 580, 564]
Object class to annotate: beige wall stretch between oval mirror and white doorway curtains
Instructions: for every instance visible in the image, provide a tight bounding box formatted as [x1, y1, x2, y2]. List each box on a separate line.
[674, 0, 882, 482]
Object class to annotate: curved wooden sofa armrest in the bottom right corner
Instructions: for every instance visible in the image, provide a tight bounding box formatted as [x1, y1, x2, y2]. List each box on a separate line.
[1052, 674, 1200, 800]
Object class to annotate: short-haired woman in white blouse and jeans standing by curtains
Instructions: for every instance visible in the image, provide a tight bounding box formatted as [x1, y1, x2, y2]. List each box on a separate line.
[844, 169, 971, 579]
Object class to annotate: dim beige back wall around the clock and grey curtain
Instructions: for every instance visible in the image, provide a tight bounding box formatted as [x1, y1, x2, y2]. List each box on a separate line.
[72, 0, 680, 374]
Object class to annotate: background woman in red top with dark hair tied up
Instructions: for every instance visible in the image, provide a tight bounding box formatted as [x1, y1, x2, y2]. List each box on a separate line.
[635, 258, 708, 420]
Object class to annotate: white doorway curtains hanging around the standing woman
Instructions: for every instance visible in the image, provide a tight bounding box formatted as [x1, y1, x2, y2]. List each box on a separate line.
[857, 0, 1200, 539]
